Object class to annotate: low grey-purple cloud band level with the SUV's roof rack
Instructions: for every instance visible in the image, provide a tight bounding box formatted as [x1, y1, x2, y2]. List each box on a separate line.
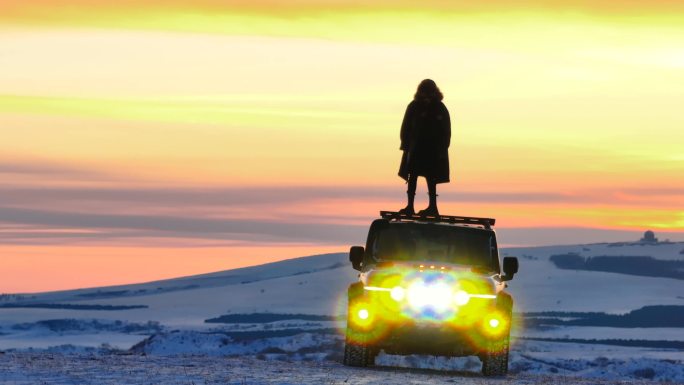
[0, 207, 683, 247]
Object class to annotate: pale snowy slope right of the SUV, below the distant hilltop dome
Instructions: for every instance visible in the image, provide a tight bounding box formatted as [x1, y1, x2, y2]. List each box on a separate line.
[502, 243, 684, 313]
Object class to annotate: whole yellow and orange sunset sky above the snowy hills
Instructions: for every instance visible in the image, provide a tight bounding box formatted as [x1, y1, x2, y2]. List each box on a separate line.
[0, 0, 684, 293]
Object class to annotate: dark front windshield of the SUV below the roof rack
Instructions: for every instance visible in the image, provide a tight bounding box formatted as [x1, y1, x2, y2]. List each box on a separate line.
[372, 223, 498, 271]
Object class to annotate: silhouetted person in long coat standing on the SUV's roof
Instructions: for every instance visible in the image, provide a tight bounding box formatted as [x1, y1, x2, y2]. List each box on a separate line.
[399, 79, 451, 215]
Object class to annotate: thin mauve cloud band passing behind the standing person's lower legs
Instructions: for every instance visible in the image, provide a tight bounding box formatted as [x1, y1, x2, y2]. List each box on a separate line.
[0, 182, 684, 207]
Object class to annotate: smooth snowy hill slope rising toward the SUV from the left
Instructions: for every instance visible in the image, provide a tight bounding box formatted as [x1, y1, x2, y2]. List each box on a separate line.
[0, 254, 356, 328]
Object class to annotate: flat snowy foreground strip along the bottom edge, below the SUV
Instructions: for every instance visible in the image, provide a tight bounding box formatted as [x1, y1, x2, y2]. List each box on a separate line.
[0, 353, 680, 385]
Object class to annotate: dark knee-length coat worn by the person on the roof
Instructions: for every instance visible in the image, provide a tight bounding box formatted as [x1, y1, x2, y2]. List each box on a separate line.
[399, 100, 451, 183]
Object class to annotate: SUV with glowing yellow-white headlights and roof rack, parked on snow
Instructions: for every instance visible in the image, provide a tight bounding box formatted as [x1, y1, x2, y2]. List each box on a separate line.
[344, 211, 518, 376]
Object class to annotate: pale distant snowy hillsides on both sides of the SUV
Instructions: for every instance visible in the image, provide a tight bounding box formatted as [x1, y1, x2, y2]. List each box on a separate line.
[0, 243, 684, 328]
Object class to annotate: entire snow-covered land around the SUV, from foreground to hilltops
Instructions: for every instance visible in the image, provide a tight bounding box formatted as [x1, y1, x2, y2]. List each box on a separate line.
[0, 243, 684, 384]
